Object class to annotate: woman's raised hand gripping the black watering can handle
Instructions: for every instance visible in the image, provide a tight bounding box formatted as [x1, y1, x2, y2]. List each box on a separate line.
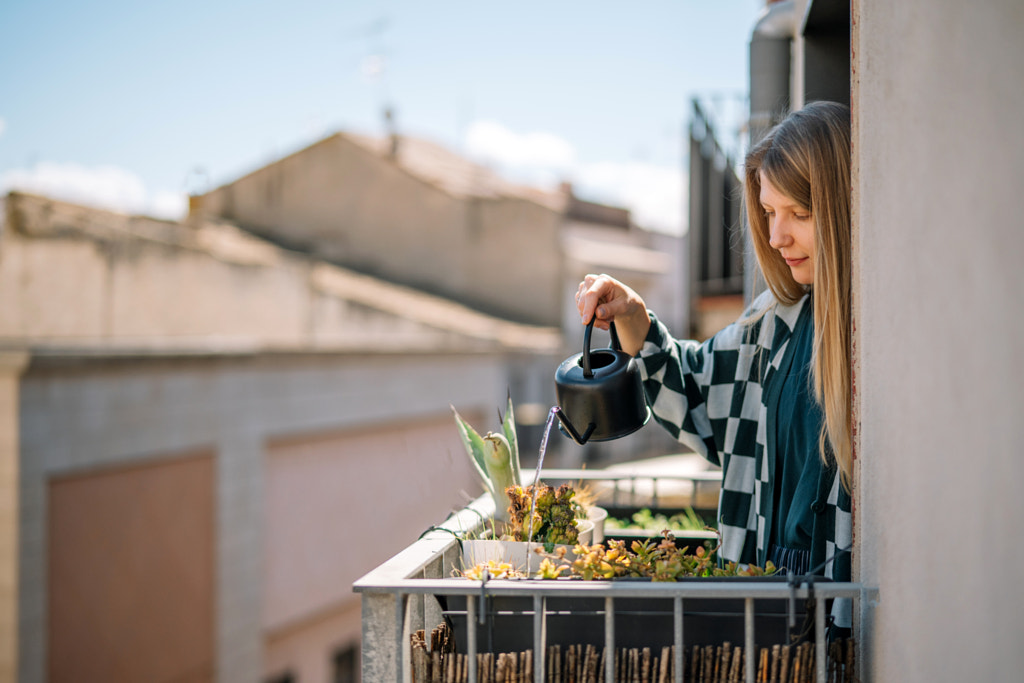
[575, 274, 650, 355]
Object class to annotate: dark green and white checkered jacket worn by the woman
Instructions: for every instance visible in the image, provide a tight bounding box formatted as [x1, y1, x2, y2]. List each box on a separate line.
[638, 292, 852, 581]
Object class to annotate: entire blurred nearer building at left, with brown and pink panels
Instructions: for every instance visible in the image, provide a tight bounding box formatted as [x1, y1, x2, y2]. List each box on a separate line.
[0, 194, 561, 683]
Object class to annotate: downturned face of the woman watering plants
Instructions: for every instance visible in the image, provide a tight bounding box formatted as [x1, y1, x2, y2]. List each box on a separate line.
[760, 173, 814, 285]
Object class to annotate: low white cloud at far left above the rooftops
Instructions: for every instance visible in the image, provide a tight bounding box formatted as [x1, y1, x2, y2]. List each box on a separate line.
[0, 162, 188, 218]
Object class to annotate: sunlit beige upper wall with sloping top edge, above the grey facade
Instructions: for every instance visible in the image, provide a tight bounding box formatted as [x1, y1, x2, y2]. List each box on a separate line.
[0, 195, 558, 351]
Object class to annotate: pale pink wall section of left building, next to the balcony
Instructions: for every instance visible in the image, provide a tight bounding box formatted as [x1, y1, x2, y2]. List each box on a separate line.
[263, 419, 487, 681]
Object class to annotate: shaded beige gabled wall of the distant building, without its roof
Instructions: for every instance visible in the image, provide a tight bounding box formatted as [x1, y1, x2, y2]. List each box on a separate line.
[197, 134, 561, 325]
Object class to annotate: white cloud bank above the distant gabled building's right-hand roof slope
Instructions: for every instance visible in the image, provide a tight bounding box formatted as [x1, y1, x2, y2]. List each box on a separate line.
[466, 121, 686, 233]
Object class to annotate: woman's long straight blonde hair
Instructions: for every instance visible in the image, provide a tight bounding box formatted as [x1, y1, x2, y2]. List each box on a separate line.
[744, 101, 853, 489]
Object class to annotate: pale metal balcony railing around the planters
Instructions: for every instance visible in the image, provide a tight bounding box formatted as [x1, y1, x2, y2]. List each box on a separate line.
[353, 470, 873, 683]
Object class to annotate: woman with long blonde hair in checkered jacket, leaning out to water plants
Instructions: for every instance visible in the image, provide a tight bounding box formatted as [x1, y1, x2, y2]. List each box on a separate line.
[577, 102, 852, 593]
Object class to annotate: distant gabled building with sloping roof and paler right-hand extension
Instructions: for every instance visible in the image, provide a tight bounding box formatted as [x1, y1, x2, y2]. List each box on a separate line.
[191, 133, 682, 335]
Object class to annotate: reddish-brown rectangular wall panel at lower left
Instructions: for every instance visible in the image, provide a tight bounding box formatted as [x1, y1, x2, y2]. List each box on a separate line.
[46, 454, 216, 683]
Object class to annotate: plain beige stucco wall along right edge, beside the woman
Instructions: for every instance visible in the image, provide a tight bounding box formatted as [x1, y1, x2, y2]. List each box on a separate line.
[853, 0, 1024, 682]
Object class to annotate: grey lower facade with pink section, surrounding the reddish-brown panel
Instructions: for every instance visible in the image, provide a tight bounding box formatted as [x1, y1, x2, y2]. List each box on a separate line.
[18, 354, 507, 683]
